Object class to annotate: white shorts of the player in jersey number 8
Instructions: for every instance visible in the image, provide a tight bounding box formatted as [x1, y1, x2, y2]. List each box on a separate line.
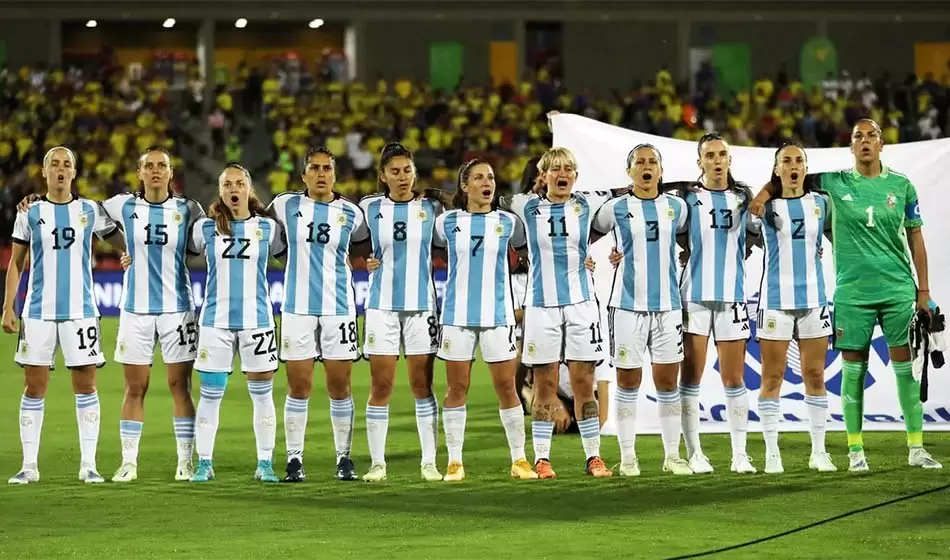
[363, 309, 439, 356]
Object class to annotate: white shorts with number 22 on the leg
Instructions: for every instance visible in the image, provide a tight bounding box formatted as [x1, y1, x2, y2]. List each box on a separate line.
[195, 327, 277, 373]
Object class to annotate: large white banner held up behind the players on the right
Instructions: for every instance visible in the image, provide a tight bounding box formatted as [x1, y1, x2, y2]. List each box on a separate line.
[553, 115, 950, 434]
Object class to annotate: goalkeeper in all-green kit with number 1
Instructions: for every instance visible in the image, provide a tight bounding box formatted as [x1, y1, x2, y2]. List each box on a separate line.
[749, 119, 941, 471]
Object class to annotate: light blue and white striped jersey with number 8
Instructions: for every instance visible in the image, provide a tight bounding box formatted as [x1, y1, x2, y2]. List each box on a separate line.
[360, 194, 442, 312]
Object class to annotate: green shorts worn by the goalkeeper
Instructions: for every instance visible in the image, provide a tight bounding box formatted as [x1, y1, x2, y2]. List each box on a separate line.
[834, 301, 917, 351]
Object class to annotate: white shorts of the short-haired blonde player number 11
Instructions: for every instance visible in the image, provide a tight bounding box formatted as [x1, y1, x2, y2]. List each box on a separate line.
[521, 301, 604, 366]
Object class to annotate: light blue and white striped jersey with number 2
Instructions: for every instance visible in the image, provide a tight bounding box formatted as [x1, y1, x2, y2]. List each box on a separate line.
[750, 193, 831, 310]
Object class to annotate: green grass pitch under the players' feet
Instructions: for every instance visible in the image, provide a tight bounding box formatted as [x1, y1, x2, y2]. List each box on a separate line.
[0, 320, 950, 560]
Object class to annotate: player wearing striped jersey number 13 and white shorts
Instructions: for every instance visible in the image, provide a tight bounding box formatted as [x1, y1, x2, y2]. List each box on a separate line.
[680, 133, 756, 473]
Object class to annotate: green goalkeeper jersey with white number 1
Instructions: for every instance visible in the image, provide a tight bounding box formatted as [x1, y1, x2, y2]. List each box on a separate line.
[818, 164, 923, 305]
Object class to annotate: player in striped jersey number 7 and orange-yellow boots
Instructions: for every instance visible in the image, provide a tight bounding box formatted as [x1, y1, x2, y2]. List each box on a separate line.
[435, 159, 538, 481]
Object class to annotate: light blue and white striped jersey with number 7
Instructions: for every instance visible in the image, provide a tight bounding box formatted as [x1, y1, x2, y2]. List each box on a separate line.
[435, 210, 525, 327]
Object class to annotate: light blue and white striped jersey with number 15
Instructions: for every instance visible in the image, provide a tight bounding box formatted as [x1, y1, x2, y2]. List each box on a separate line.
[102, 193, 205, 315]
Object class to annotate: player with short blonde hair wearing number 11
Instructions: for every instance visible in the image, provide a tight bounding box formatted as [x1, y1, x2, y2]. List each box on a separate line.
[502, 148, 613, 478]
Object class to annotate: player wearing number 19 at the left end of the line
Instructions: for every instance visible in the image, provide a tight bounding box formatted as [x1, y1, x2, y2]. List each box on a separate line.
[2, 146, 116, 484]
